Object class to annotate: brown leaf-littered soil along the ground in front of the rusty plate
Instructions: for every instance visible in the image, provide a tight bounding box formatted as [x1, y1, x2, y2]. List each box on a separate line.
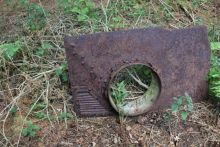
[31, 102, 220, 147]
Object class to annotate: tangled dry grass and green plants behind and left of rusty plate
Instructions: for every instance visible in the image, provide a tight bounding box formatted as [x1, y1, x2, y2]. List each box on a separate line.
[0, 0, 220, 146]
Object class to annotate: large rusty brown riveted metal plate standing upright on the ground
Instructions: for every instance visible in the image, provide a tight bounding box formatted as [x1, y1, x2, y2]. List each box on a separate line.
[64, 26, 210, 116]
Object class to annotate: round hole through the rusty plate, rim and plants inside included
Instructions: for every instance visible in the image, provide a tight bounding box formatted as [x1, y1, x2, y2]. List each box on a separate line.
[108, 64, 161, 116]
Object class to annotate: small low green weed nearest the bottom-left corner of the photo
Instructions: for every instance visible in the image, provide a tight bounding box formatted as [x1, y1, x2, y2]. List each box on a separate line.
[21, 121, 41, 137]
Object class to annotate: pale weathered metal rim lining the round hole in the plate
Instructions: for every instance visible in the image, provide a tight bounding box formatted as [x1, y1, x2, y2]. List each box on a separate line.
[108, 63, 161, 116]
